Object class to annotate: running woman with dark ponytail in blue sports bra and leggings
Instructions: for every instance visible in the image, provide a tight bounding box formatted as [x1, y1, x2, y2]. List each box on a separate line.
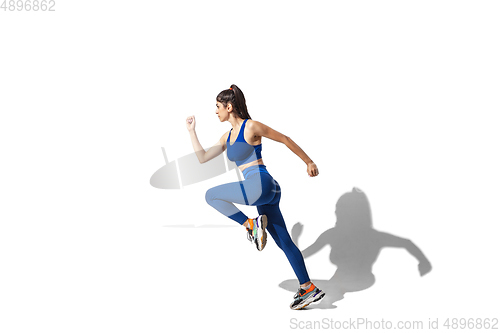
[186, 84, 325, 310]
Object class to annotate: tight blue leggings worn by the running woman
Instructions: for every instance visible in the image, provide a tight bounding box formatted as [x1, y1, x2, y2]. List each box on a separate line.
[205, 165, 309, 284]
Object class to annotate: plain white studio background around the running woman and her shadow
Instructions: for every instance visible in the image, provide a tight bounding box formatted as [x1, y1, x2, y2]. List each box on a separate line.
[0, 1, 500, 333]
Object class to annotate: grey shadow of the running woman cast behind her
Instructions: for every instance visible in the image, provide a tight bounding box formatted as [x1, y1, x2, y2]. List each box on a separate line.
[279, 188, 432, 309]
